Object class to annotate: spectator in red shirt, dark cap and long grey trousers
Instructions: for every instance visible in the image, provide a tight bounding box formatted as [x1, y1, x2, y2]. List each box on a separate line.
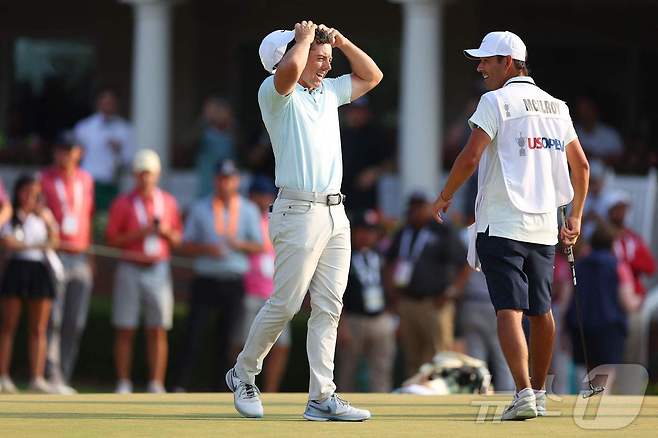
[41, 134, 94, 394]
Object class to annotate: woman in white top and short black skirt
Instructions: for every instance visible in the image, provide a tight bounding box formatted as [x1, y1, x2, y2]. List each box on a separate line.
[0, 176, 59, 393]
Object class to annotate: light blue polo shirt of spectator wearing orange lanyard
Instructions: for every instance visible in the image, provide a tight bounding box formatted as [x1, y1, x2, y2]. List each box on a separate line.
[183, 195, 263, 279]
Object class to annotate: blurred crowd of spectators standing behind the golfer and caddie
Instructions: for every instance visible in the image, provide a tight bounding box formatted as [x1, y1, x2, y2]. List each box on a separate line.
[0, 89, 655, 394]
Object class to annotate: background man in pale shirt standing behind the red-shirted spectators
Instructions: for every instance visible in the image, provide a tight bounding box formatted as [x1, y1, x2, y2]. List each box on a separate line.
[74, 89, 135, 211]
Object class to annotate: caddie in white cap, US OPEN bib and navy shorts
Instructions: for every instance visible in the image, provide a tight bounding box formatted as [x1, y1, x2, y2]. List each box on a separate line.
[434, 32, 589, 420]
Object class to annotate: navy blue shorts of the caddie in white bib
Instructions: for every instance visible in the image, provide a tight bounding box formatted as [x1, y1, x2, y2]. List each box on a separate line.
[476, 230, 555, 316]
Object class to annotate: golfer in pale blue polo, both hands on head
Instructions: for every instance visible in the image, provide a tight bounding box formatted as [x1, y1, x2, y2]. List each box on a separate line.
[226, 21, 383, 421]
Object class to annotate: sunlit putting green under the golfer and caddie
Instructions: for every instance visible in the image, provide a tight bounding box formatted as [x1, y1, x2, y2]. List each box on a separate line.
[0, 394, 658, 438]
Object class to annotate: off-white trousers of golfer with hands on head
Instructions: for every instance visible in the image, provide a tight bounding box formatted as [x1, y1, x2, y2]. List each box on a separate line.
[235, 198, 351, 400]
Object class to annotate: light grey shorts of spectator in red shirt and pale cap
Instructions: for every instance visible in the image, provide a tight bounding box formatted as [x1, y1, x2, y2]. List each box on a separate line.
[112, 262, 174, 330]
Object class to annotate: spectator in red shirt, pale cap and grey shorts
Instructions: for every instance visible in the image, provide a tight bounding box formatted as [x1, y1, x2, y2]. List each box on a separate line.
[106, 149, 182, 394]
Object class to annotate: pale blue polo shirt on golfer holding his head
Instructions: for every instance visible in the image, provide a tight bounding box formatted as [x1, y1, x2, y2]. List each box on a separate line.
[258, 74, 352, 193]
